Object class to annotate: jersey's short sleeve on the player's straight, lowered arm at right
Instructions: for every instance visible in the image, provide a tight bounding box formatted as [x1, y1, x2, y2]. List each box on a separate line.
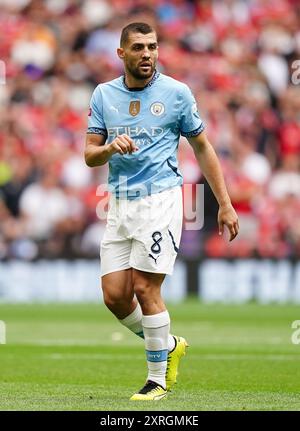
[180, 85, 204, 138]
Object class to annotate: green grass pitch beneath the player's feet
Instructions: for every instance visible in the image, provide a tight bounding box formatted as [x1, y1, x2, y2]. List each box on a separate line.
[0, 299, 300, 411]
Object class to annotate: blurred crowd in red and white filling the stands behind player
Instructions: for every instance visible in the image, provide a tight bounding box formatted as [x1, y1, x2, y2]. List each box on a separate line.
[0, 0, 300, 260]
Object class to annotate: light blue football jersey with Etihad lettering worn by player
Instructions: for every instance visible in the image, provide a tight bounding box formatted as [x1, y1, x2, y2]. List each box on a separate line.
[87, 71, 204, 199]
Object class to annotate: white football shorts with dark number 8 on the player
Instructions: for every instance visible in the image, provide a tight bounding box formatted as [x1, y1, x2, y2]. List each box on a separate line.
[100, 186, 182, 276]
